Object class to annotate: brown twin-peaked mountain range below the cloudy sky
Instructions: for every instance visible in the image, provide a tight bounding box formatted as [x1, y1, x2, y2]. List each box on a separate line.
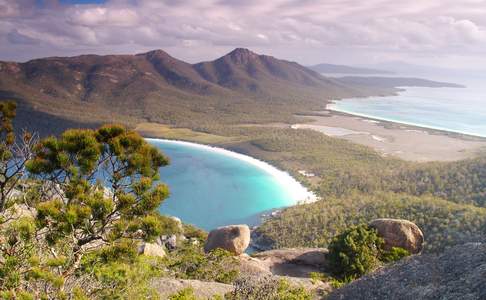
[0, 48, 460, 134]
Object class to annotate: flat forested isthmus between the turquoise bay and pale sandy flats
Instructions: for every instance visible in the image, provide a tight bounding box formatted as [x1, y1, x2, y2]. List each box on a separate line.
[236, 127, 486, 207]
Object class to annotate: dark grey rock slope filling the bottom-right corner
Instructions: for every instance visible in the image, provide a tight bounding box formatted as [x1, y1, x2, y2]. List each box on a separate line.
[329, 242, 486, 300]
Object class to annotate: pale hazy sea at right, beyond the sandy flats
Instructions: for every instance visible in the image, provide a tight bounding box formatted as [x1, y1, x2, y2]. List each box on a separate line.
[328, 77, 486, 137]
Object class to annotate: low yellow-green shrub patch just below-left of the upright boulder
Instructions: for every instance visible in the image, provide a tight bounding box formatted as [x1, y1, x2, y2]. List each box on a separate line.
[165, 242, 239, 283]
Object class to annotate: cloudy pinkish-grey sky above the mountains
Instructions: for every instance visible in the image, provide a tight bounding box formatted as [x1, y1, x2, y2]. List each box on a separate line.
[0, 0, 486, 68]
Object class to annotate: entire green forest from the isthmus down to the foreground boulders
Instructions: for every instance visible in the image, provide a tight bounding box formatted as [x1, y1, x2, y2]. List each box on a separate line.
[225, 128, 486, 252]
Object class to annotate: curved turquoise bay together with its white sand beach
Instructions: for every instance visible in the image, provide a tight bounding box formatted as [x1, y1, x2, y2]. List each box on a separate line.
[148, 139, 306, 230]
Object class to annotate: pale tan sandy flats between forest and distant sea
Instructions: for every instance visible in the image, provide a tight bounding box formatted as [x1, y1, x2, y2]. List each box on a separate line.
[293, 114, 486, 162]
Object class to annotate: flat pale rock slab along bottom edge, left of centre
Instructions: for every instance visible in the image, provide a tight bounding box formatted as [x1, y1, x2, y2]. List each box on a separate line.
[152, 278, 233, 299]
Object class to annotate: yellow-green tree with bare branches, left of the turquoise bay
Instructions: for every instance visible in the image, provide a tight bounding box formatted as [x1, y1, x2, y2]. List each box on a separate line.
[27, 125, 168, 248]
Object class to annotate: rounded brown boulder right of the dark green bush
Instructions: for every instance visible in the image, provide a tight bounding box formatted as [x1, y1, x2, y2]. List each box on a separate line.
[369, 219, 424, 254]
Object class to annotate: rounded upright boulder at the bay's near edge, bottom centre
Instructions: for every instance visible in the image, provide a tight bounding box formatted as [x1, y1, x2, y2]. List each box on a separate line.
[204, 225, 250, 255]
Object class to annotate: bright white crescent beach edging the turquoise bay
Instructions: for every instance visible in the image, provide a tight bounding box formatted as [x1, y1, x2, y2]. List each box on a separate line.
[144, 137, 319, 204]
